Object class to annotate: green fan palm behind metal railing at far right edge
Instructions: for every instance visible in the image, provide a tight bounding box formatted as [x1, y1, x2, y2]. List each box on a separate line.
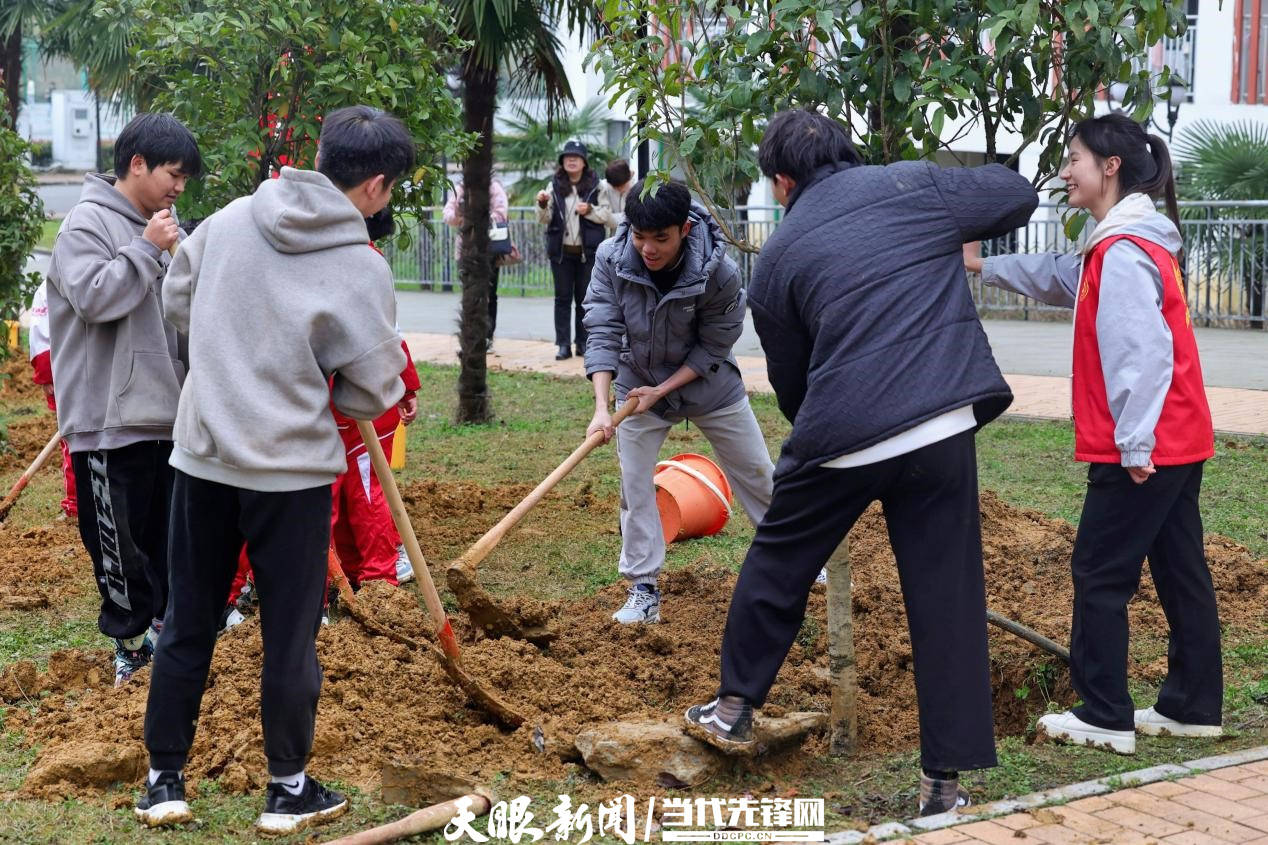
[1175, 121, 1268, 329]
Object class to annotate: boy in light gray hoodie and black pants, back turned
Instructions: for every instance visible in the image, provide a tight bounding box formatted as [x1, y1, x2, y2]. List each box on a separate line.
[136, 107, 413, 834]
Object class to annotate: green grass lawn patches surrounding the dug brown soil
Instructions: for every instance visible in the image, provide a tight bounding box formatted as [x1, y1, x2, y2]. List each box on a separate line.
[0, 357, 1268, 842]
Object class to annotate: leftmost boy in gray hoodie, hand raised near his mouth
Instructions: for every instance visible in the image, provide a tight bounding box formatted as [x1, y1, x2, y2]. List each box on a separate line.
[47, 114, 202, 685]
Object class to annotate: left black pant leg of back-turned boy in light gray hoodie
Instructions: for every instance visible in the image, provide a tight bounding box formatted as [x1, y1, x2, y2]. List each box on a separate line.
[146, 472, 242, 769]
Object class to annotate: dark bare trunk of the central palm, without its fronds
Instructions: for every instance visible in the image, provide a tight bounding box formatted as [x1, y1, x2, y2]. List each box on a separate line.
[458, 56, 497, 423]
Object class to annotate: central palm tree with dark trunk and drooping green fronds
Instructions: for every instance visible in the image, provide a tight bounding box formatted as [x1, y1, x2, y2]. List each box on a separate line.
[453, 0, 592, 423]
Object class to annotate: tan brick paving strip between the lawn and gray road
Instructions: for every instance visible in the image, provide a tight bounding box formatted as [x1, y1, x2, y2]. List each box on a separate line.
[402, 329, 1268, 435]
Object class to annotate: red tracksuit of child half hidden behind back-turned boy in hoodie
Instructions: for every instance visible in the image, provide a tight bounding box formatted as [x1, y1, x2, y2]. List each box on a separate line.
[230, 340, 420, 603]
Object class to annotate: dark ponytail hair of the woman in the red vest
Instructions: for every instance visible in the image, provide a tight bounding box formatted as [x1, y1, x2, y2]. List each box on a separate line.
[1070, 112, 1181, 228]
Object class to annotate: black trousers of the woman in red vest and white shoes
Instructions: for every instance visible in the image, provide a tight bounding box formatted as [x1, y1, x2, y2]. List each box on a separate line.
[1070, 462, 1224, 731]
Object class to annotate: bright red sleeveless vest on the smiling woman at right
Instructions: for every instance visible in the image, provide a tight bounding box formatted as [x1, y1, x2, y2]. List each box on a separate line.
[1073, 235, 1215, 467]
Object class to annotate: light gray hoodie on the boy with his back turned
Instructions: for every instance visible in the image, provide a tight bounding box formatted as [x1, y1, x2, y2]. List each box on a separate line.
[164, 167, 406, 492]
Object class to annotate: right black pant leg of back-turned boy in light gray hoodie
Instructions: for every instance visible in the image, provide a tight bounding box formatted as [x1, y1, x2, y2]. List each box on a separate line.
[239, 486, 331, 778]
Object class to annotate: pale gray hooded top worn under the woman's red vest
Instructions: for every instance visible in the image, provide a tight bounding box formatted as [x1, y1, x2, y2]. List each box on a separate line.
[981, 194, 1183, 467]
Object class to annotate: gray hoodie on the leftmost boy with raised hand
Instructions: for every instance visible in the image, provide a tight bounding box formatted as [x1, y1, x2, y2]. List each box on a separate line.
[48, 174, 185, 452]
